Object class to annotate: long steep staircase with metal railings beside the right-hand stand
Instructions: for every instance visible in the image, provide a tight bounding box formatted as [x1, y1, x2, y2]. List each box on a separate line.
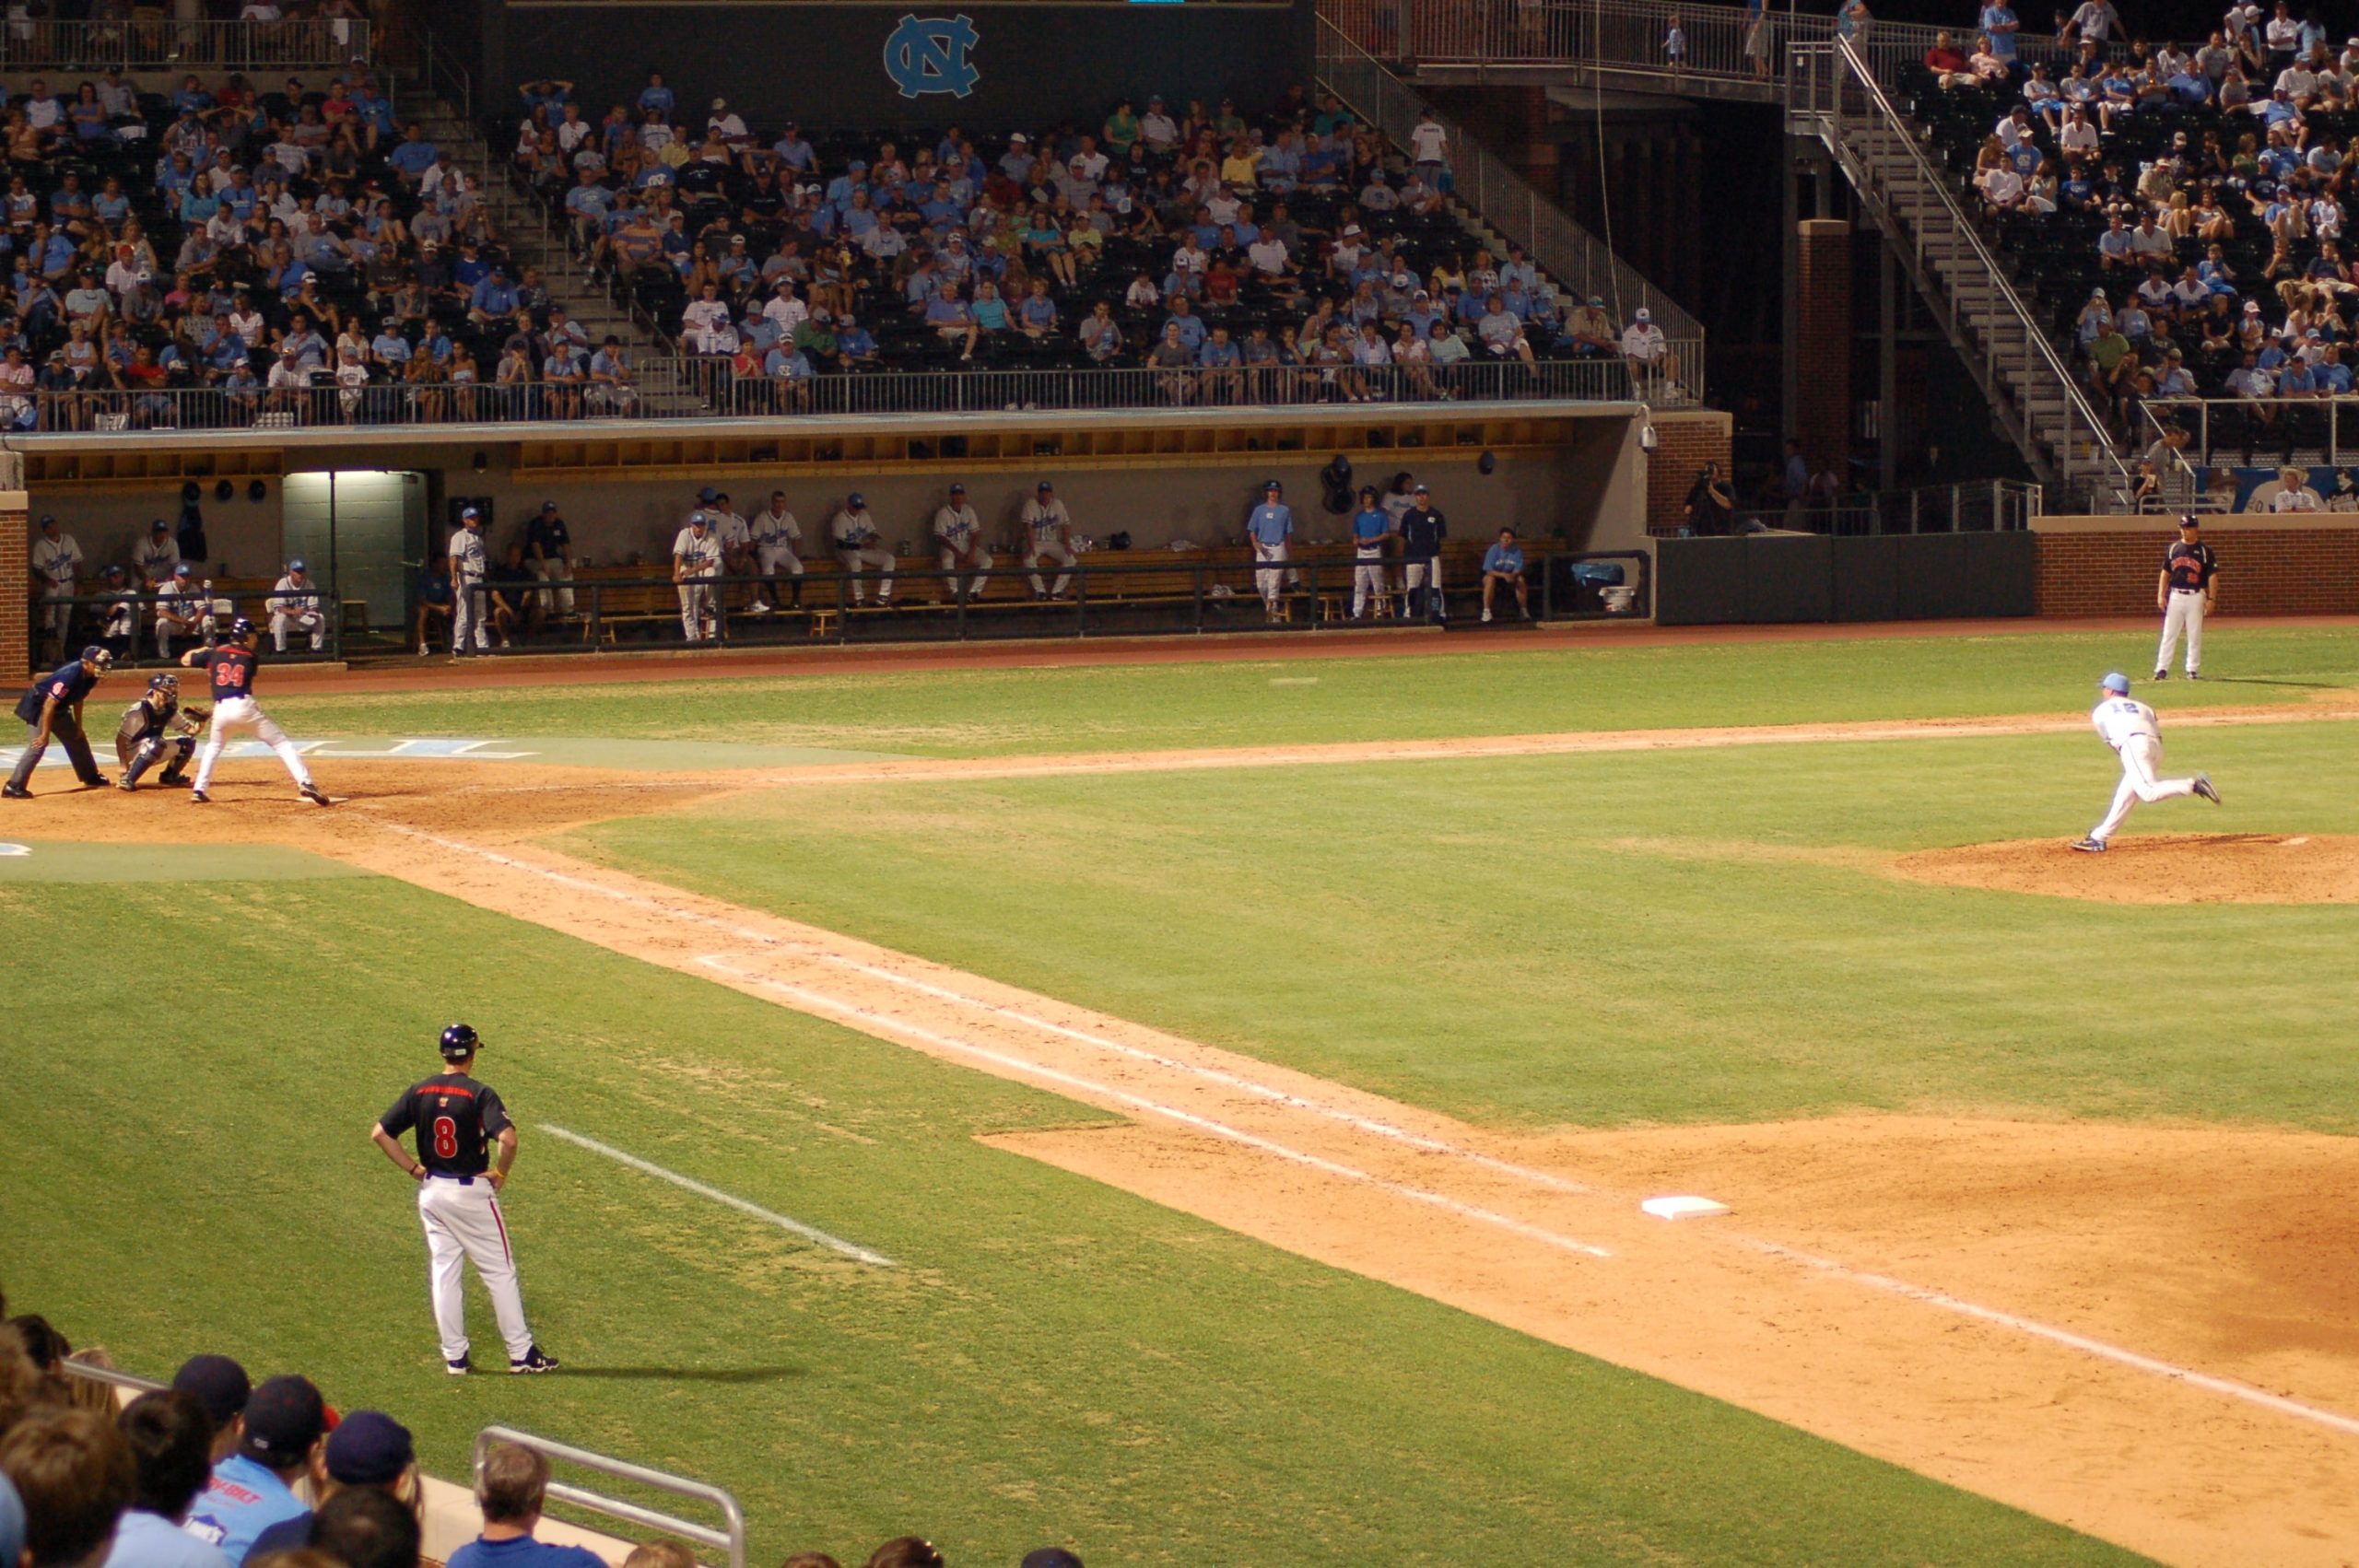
[1788, 42, 2130, 509]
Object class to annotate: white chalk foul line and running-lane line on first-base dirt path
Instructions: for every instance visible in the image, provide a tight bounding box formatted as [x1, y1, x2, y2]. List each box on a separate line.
[382, 823, 2359, 1436]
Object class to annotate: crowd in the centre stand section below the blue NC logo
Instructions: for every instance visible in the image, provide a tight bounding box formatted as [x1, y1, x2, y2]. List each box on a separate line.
[514, 71, 1677, 408]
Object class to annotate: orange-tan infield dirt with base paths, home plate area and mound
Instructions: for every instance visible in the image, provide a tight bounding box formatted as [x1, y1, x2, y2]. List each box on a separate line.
[41, 714, 2359, 1565]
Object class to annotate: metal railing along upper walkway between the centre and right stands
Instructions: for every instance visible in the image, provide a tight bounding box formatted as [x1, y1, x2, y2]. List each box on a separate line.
[1319, 0, 2069, 99]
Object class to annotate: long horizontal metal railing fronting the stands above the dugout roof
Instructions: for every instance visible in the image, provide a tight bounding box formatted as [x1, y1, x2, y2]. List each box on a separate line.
[14, 342, 1703, 439]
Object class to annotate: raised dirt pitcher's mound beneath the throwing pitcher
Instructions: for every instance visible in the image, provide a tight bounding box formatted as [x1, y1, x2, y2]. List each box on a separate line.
[1892, 832, 2359, 903]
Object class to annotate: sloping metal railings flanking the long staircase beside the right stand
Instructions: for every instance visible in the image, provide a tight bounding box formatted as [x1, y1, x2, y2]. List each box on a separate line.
[1793, 38, 2130, 502]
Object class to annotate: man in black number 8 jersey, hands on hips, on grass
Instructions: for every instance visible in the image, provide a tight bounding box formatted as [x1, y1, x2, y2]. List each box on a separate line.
[368, 1024, 557, 1377]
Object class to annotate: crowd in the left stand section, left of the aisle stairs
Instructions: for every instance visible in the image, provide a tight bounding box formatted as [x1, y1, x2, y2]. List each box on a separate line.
[0, 52, 608, 429]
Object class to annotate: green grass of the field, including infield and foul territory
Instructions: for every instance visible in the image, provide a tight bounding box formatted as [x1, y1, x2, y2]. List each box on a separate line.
[0, 627, 2359, 1568]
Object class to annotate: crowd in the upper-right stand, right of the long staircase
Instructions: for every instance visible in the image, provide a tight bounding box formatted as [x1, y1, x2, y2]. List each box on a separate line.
[1904, 0, 2359, 464]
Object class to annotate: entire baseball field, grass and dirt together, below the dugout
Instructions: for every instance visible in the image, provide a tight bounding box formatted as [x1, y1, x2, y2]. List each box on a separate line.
[0, 623, 2359, 1568]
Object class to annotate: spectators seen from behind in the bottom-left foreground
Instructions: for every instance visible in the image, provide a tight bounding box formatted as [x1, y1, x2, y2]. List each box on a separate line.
[0, 1304, 1083, 1568]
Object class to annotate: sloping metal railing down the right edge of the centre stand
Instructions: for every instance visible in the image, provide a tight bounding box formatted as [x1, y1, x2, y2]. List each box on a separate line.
[1316, 17, 1703, 399]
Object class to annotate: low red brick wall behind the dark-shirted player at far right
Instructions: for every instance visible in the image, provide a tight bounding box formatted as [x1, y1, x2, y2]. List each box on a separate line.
[2038, 519, 2359, 615]
